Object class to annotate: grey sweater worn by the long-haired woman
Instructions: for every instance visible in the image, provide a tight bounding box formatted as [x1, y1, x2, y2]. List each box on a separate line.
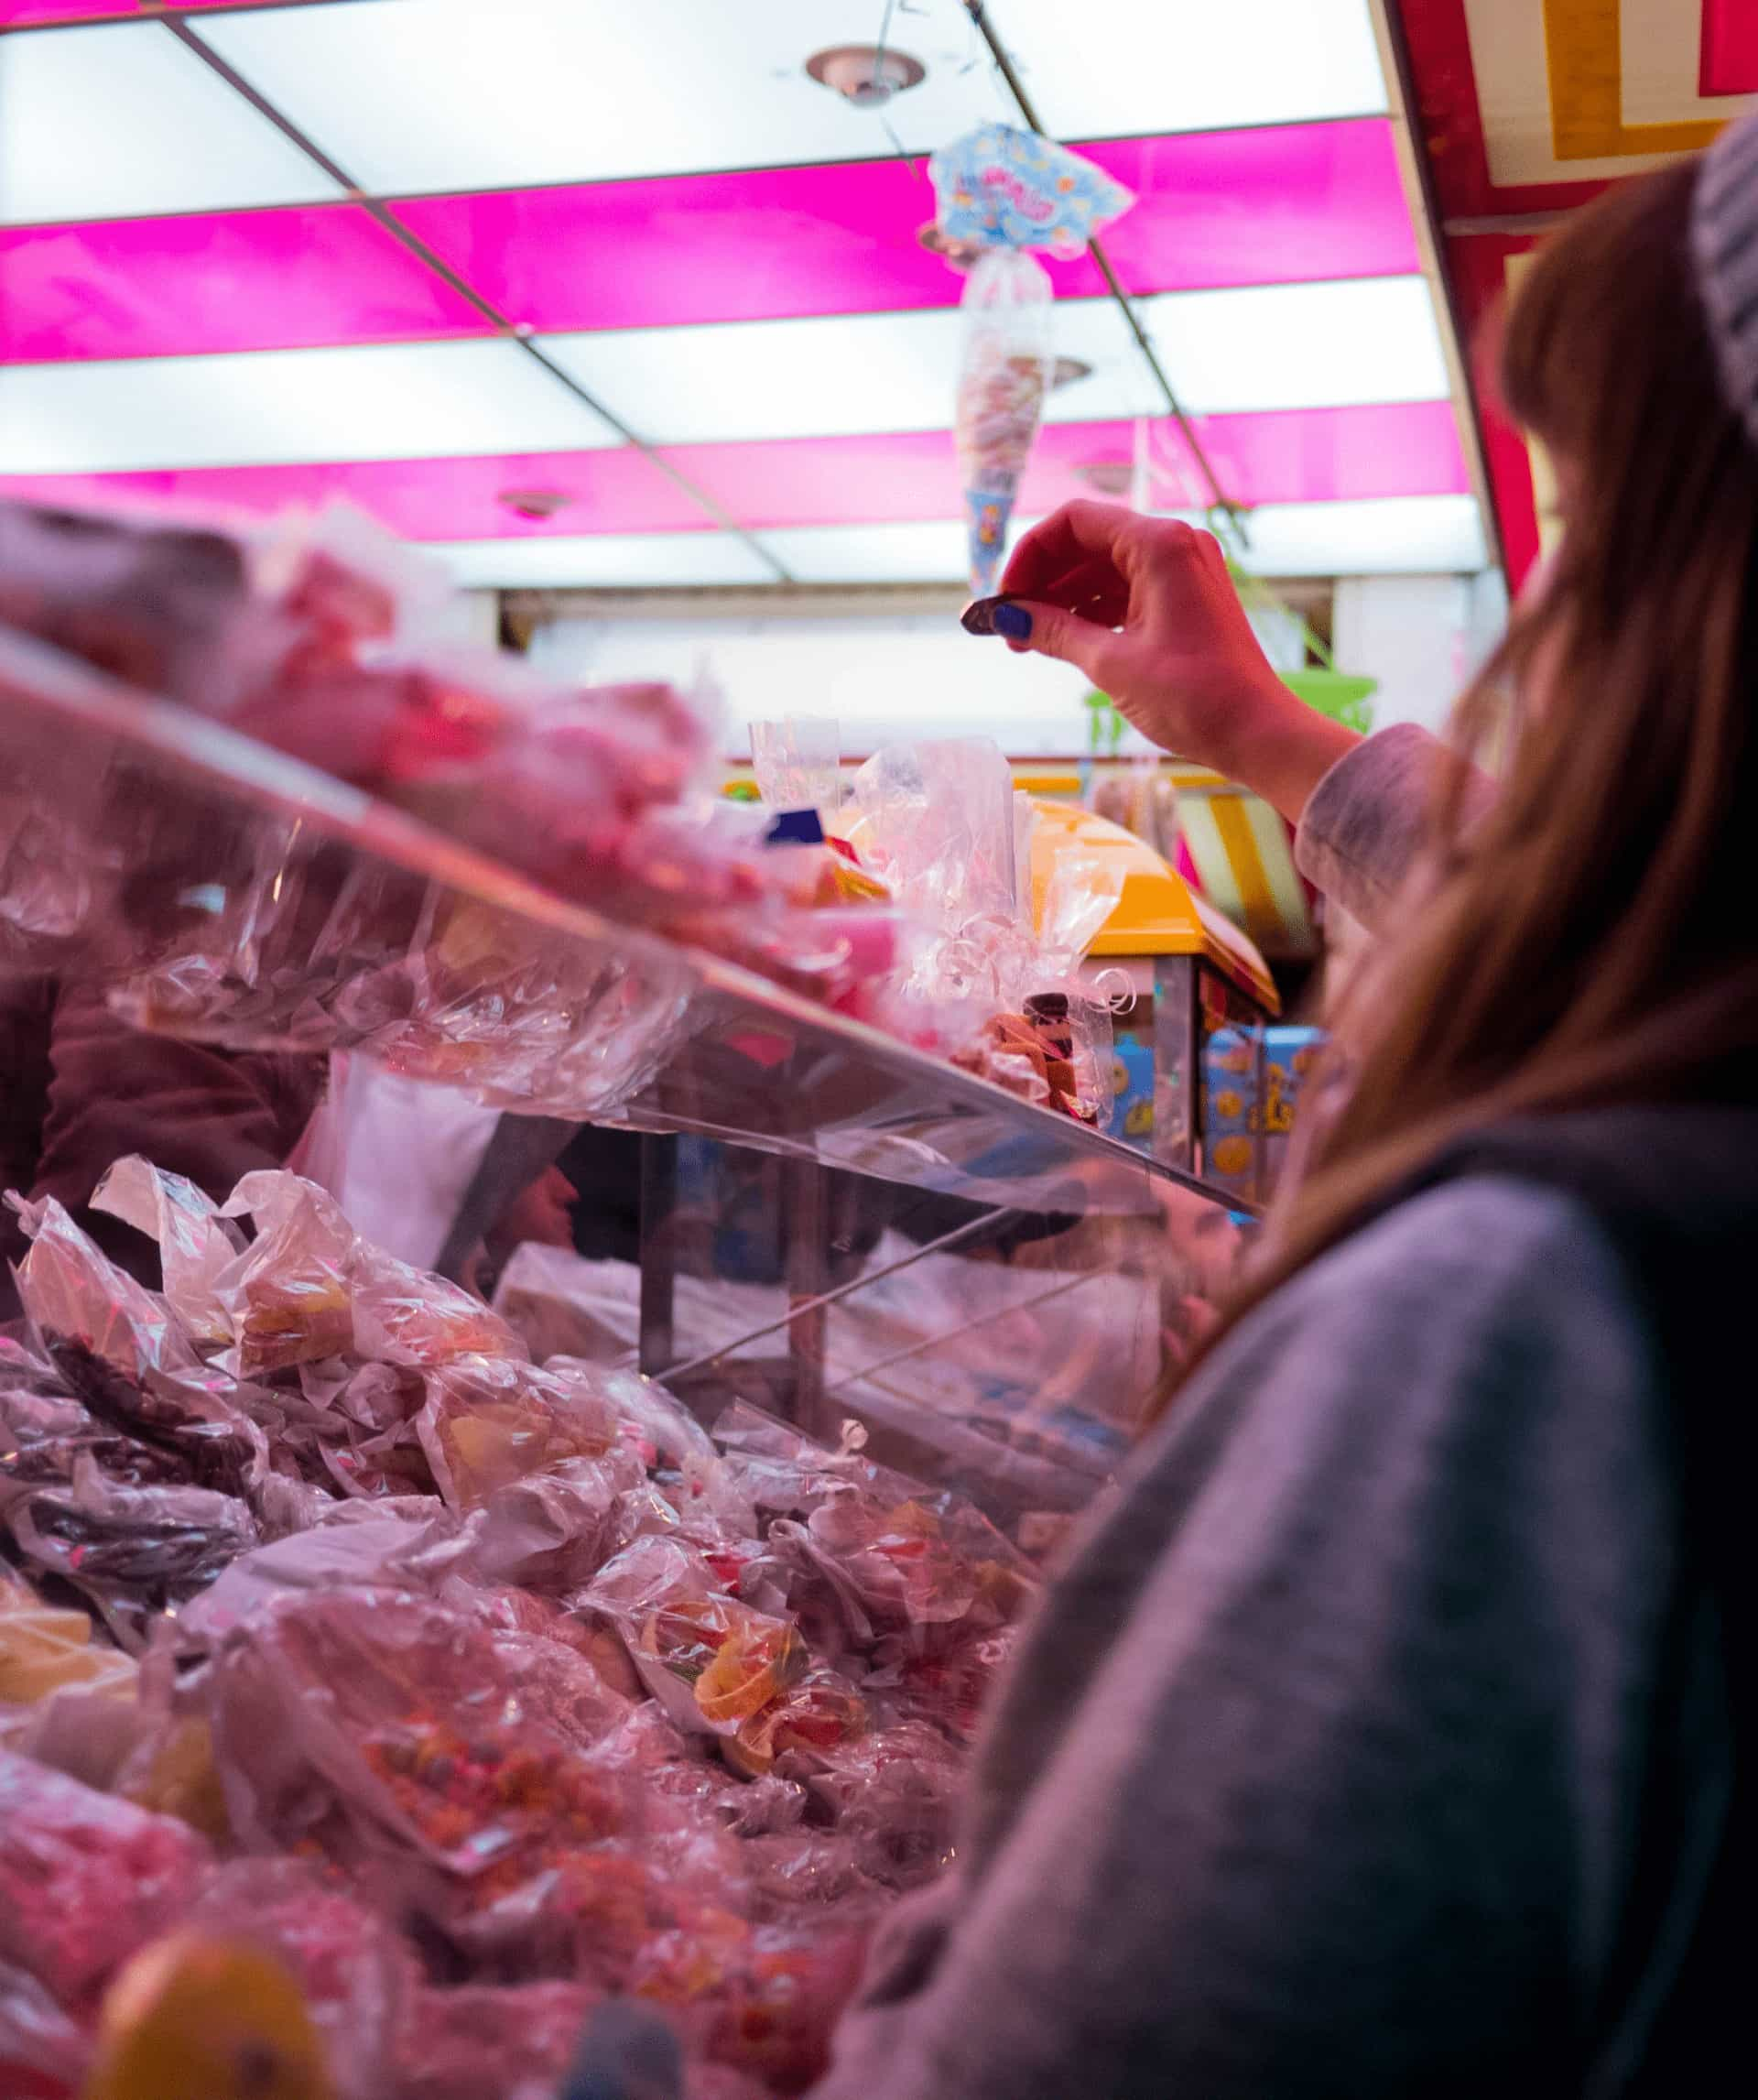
[817, 733, 1729, 2100]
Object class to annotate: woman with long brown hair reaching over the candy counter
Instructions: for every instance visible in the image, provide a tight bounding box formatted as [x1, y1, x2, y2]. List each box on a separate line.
[819, 126, 1758, 2100]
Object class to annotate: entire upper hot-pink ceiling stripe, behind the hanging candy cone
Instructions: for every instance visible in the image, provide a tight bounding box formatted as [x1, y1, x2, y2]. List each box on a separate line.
[0, 125, 1416, 364]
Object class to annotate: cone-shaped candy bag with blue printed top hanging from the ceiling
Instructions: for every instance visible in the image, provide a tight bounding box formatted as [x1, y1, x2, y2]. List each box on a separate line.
[928, 124, 1134, 596]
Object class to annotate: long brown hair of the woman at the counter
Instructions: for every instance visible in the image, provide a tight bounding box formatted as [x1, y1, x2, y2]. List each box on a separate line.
[1176, 164, 1758, 1377]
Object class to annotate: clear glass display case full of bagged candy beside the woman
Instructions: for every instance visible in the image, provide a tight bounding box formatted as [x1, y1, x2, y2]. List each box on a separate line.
[0, 613, 1250, 2100]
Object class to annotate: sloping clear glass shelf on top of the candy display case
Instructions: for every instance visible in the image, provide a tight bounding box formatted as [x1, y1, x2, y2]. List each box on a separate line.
[0, 630, 1239, 1216]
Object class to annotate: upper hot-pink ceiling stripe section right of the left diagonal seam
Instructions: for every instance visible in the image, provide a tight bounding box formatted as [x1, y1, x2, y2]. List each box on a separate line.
[395, 117, 1417, 330]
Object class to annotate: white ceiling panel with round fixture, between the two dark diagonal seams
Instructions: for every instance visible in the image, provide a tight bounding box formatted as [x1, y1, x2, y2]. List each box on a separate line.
[201, 0, 1008, 193]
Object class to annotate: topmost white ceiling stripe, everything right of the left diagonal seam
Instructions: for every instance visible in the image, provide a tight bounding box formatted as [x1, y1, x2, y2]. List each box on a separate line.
[204, 0, 1386, 193]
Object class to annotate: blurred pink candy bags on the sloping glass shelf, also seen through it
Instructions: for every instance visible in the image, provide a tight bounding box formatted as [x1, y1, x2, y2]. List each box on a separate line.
[0, 502, 1109, 1119]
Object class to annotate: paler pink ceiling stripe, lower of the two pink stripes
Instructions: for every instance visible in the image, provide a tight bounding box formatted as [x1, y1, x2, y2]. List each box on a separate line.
[0, 401, 1470, 539]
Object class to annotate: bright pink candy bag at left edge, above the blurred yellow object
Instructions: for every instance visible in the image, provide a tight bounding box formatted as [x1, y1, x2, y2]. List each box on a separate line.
[0, 1751, 210, 2012]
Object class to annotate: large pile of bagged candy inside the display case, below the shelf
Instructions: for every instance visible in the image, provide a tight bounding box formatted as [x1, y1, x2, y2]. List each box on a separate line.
[0, 1159, 1034, 2100]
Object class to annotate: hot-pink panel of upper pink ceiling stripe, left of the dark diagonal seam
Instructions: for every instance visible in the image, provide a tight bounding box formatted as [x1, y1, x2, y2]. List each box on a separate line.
[0, 203, 492, 364]
